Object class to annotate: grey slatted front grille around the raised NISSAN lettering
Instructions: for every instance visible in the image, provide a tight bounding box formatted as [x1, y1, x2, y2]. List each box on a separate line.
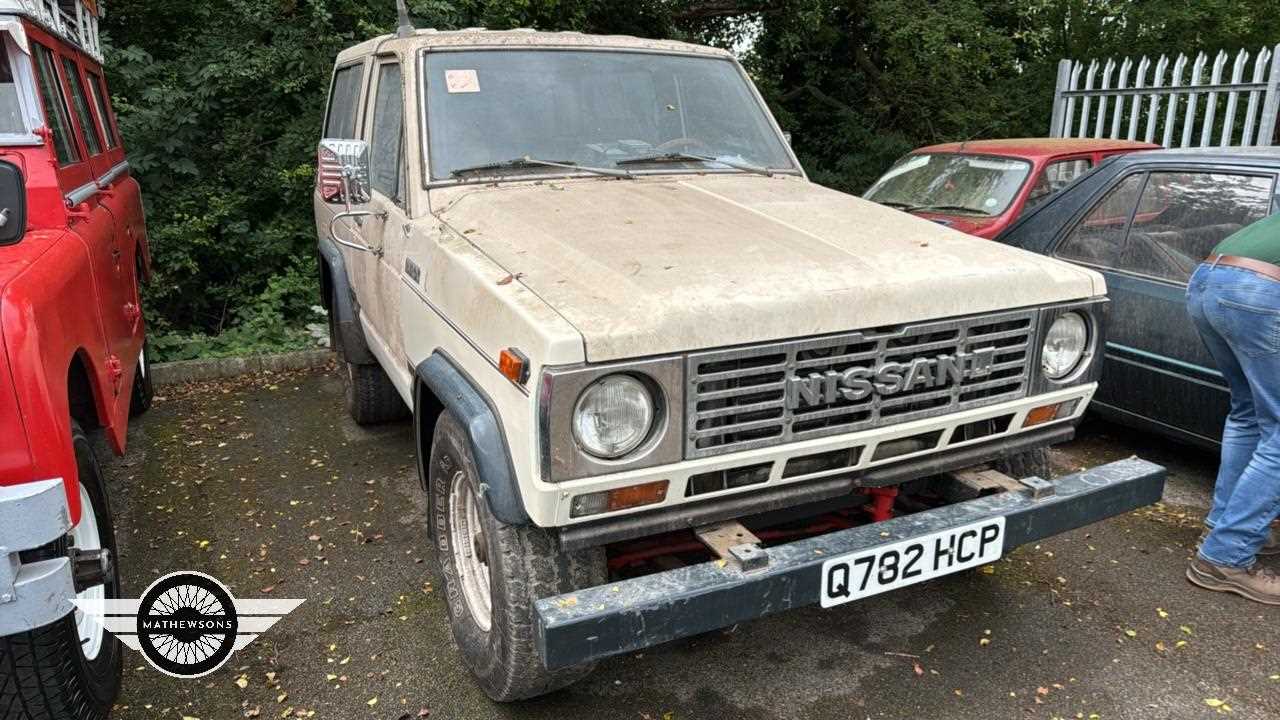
[685, 310, 1037, 457]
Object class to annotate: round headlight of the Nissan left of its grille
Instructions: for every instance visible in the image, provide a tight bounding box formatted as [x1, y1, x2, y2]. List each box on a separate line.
[573, 375, 654, 460]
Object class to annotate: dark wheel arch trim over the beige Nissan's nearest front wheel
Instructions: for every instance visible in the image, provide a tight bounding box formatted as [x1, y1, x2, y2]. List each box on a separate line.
[413, 350, 531, 525]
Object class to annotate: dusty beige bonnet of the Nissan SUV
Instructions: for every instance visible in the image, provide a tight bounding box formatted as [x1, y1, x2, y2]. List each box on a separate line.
[431, 176, 1105, 361]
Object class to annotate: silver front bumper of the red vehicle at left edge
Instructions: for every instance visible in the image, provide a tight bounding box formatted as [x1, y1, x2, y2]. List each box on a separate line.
[0, 479, 76, 637]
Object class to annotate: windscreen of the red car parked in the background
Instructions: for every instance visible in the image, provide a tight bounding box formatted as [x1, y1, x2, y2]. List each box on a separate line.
[864, 154, 1032, 217]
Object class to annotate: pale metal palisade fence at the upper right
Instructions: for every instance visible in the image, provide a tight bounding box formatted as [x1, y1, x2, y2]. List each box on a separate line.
[1050, 45, 1280, 147]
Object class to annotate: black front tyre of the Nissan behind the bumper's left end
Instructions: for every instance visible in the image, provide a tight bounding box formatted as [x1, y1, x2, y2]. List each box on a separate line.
[426, 411, 607, 702]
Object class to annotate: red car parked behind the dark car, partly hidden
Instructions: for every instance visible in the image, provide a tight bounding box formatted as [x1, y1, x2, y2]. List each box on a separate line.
[863, 137, 1160, 238]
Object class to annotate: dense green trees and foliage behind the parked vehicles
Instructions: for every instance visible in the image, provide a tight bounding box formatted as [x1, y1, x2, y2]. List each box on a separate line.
[102, 0, 1280, 359]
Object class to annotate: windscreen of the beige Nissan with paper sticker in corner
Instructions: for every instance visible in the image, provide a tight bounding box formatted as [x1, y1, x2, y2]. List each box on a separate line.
[425, 50, 794, 179]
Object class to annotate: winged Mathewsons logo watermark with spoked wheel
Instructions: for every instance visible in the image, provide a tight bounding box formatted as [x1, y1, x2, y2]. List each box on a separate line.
[72, 571, 303, 678]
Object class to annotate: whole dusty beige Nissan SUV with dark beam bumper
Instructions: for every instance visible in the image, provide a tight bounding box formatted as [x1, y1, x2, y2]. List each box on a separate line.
[314, 26, 1164, 701]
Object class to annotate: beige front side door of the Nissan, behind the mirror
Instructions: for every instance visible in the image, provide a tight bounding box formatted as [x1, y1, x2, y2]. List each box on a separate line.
[352, 55, 408, 380]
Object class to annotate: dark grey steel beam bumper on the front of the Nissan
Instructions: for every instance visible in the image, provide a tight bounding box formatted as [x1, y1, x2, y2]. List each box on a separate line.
[535, 459, 1165, 669]
